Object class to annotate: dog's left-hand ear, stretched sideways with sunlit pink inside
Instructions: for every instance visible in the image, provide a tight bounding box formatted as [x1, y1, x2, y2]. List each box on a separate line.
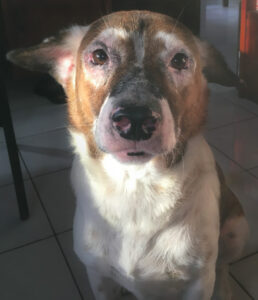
[7, 26, 88, 87]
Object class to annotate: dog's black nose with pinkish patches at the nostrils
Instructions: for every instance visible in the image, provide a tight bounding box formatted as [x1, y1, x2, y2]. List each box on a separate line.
[111, 106, 160, 141]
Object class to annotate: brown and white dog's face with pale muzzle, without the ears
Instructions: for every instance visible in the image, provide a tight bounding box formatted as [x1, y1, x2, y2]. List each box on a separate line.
[79, 12, 206, 162]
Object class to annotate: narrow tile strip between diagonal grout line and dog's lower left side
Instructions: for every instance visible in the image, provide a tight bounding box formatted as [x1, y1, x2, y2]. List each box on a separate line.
[58, 231, 94, 300]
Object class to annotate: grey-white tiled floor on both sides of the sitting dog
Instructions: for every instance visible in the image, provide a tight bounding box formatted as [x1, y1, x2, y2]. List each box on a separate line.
[0, 1, 258, 300]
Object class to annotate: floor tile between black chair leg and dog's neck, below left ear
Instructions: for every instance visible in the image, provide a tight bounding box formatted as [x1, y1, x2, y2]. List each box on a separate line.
[2, 104, 67, 141]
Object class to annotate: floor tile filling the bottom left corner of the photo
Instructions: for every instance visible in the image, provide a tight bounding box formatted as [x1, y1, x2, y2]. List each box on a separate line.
[0, 238, 81, 300]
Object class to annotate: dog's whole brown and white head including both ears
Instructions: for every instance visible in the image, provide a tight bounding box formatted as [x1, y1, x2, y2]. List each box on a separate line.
[8, 11, 239, 163]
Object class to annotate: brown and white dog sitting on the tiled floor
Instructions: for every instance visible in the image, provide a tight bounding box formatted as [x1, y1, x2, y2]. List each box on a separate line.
[7, 11, 248, 300]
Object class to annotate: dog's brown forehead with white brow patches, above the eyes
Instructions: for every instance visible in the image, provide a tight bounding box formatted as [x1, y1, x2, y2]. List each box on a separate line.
[80, 11, 196, 48]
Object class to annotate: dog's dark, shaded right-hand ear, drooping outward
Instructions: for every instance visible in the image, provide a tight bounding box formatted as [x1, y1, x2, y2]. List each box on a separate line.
[196, 39, 240, 87]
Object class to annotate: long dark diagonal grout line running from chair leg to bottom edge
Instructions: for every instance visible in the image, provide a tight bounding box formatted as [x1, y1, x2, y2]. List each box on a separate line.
[18, 152, 84, 300]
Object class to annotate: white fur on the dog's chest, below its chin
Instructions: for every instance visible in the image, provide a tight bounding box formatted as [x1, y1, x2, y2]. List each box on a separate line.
[72, 133, 219, 289]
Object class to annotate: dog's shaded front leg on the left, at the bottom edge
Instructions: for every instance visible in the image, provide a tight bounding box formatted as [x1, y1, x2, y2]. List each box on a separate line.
[87, 268, 125, 300]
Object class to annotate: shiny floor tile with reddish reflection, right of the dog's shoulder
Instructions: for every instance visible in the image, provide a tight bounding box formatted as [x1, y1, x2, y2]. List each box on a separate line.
[206, 118, 258, 169]
